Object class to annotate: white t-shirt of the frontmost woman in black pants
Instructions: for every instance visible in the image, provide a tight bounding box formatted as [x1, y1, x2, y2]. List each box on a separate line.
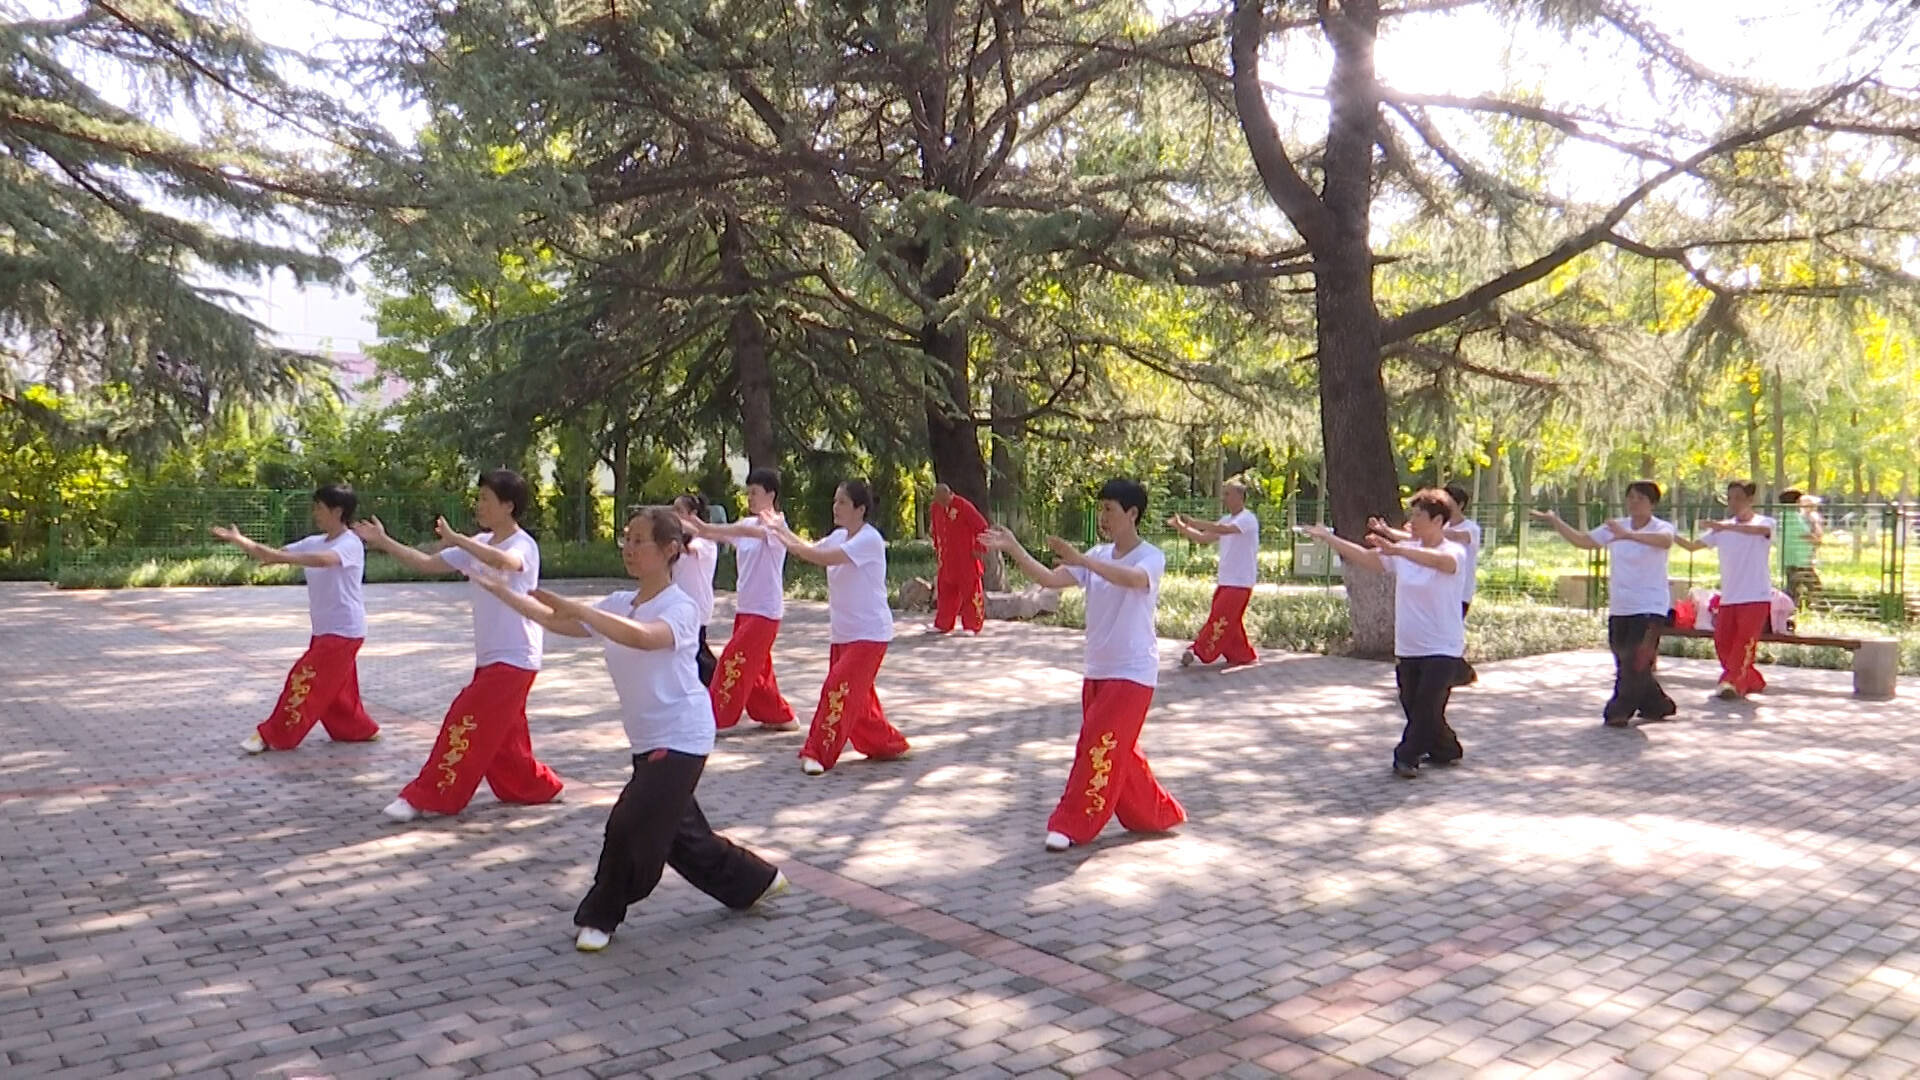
[589, 584, 714, 757]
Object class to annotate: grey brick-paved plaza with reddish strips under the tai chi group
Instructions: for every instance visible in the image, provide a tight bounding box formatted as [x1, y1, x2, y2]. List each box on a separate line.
[0, 582, 1920, 1078]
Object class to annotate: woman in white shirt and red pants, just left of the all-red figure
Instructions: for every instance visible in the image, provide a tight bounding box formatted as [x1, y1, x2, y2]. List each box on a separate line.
[760, 480, 906, 776]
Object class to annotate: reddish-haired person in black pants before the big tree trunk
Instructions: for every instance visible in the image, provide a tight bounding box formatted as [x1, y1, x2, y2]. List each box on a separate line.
[1304, 488, 1467, 780]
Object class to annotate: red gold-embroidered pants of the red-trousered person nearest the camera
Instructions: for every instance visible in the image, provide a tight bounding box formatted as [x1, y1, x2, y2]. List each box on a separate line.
[1046, 678, 1187, 844]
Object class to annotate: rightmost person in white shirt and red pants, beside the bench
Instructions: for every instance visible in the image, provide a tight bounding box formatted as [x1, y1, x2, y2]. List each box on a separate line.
[1678, 480, 1774, 701]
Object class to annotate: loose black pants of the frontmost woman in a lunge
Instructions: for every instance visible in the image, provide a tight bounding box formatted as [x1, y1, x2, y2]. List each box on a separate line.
[574, 749, 776, 934]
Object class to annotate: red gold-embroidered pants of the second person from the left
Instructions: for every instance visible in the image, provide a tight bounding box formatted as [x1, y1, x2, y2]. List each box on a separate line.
[399, 663, 561, 813]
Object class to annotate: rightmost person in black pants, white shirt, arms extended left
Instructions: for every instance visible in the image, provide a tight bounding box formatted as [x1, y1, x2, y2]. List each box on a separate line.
[1532, 480, 1680, 728]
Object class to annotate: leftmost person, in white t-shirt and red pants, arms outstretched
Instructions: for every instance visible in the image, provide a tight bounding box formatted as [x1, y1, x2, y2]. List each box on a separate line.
[213, 484, 380, 753]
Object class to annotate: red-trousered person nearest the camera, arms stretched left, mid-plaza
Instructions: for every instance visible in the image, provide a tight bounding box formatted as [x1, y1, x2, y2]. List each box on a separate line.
[989, 479, 1187, 851]
